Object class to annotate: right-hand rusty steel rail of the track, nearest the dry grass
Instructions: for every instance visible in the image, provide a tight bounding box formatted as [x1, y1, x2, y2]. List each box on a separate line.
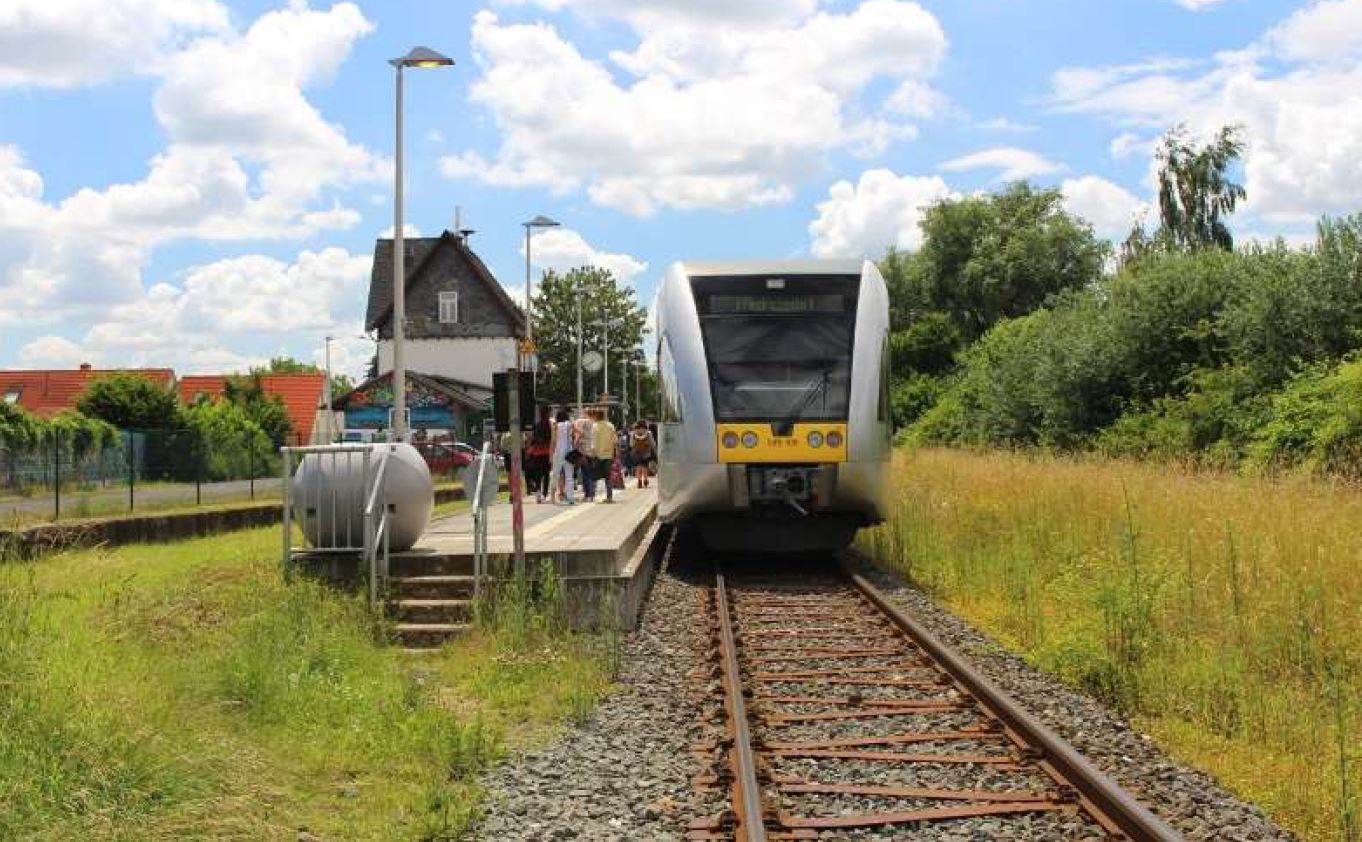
[844, 568, 1182, 842]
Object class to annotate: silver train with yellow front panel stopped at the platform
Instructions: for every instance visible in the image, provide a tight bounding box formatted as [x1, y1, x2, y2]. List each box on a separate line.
[656, 260, 892, 552]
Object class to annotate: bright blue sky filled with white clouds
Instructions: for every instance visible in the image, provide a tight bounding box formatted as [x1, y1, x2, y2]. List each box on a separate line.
[0, 0, 1362, 375]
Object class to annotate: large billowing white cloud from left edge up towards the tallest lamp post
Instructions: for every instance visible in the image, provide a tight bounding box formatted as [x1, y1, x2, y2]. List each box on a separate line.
[0, 0, 388, 323]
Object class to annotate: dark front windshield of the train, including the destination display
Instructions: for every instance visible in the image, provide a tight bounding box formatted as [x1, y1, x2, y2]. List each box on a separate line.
[691, 275, 861, 424]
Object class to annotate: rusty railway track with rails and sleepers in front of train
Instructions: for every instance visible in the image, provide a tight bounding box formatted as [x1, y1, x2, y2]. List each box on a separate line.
[688, 561, 1179, 842]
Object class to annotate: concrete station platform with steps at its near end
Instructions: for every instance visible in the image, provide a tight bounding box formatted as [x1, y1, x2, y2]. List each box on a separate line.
[388, 481, 662, 646]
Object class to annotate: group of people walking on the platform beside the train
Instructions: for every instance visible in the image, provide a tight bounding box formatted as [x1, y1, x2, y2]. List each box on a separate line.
[512, 406, 658, 505]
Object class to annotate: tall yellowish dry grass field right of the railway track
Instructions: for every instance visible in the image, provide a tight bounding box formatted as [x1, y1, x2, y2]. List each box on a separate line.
[862, 441, 1362, 842]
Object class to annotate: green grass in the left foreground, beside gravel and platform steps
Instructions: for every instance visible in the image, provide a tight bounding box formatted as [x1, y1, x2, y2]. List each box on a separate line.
[0, 527, 609, 841]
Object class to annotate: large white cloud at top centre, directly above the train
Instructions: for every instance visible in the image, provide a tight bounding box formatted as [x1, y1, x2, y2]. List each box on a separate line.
[441, 0, 945, 215]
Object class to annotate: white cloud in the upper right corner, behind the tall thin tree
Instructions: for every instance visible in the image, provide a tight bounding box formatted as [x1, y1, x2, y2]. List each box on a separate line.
[1054, 0, 1362, 226]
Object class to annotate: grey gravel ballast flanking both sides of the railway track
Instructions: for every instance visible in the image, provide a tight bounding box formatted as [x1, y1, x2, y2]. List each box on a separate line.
[477, 536, 1295, 841]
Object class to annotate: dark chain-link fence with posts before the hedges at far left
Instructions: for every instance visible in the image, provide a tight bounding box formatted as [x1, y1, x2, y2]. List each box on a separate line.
[0, 428, 302, 523]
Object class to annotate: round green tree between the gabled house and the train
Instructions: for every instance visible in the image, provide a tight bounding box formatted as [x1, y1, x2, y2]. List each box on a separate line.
[531, 267, 647, 403]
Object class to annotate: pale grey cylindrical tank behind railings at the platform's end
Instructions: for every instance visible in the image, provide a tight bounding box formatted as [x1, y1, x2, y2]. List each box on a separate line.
[293, 443, 434, 552]
